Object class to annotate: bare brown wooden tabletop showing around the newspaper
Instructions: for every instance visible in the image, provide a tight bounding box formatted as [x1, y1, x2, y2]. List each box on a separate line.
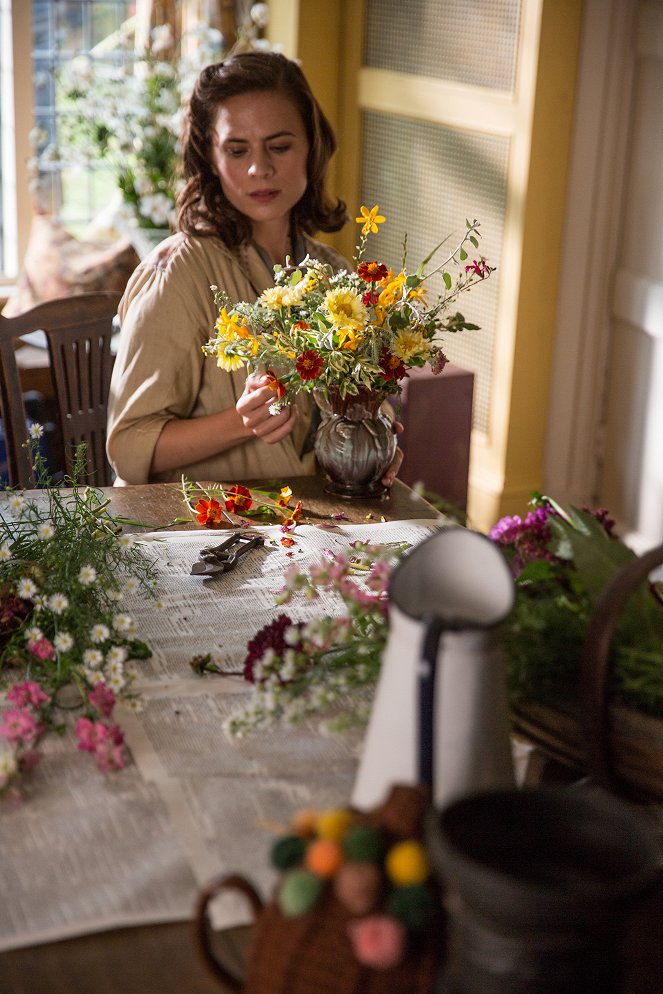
[0, 477, 438, 994]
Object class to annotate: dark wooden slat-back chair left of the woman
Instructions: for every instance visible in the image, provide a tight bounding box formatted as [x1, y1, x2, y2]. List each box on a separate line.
[0, 291, 121, 487]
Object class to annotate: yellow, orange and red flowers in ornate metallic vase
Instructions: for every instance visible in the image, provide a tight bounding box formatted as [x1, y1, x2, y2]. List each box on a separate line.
[203, 205, 493, 497]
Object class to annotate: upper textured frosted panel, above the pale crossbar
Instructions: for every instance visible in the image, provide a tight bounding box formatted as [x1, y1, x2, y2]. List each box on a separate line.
[364, 0, 522, 92]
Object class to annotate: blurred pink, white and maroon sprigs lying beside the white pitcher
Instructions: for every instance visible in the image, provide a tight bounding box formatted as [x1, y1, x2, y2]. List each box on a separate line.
[225, 542, 407, 736]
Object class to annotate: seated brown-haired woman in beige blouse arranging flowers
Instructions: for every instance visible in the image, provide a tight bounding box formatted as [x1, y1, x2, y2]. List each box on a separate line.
[108, 52, 402, 485]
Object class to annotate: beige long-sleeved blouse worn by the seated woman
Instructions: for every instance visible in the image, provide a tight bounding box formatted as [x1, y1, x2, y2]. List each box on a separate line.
[107, 235, 348, 486]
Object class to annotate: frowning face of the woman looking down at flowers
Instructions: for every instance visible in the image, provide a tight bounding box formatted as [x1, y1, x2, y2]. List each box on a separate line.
[211, 90, 308, 236]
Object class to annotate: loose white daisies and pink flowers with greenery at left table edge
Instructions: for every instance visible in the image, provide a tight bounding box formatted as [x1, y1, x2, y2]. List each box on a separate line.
[0, 434, 155, 799]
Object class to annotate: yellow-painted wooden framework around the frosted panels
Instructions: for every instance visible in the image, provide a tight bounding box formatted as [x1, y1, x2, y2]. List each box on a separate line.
[270, 0, 582, 530]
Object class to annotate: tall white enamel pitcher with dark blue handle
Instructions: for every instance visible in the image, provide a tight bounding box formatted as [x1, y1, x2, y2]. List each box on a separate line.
[352, 526, 515, 810]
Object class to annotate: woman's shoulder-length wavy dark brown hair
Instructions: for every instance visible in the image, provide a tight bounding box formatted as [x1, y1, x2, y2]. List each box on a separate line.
[177, 52, 347, 248]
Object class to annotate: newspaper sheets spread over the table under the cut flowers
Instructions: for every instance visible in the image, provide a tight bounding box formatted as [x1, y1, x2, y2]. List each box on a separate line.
[0, 521, 437, 951]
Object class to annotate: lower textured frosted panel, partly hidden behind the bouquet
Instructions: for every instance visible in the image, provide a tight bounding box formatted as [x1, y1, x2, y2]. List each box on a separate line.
[361, 111, 509, 433]
